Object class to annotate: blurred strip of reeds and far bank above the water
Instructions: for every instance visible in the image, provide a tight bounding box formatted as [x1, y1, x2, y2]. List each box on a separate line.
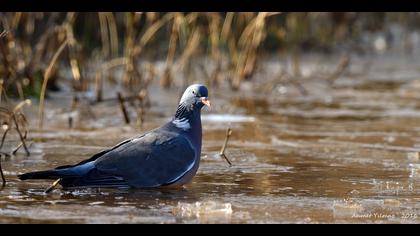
[0, 12, 420, 98]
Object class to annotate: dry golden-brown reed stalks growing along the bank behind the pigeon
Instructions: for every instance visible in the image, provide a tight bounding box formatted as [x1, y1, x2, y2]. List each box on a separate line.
[0, 12, 394, 97]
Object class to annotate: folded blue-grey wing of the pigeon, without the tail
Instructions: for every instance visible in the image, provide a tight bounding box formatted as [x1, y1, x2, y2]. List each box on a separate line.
[95, 130, 196, 187]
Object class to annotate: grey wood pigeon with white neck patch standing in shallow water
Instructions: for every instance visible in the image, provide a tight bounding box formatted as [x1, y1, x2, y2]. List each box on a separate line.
[18, 84, 210, 188]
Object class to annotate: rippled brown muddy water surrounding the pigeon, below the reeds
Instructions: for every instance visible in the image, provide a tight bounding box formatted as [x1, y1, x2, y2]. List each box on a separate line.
[0, 54, 420, 223]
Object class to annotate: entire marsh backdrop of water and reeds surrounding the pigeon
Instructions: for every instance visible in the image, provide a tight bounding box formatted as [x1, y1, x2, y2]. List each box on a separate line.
[0, 12, 420, 223]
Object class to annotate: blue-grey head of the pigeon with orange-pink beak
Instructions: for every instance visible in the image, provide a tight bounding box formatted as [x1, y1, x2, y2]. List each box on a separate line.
[179, 84, 210, 109]
